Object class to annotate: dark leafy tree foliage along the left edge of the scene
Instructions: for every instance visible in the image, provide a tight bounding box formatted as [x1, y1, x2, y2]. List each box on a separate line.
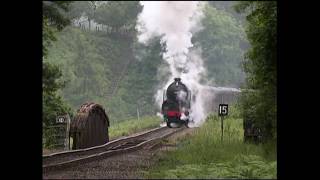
[42, 1, 71, 146]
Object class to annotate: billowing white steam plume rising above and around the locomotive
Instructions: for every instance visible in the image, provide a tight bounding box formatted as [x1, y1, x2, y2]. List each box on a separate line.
[136, 1, 205, 125]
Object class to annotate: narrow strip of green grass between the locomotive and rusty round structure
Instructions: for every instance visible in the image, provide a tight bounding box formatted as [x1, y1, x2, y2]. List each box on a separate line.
[109, 116, 162, 139]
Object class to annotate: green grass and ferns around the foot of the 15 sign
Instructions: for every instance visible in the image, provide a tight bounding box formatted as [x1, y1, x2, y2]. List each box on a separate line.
[144, 116, 277, 179]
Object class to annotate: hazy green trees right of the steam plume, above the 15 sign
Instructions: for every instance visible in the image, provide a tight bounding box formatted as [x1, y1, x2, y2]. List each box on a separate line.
[193, 2, 248, 87]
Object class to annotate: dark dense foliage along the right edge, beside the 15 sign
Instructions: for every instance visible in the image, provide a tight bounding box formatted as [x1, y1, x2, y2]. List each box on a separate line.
[235, 1, 277, 140]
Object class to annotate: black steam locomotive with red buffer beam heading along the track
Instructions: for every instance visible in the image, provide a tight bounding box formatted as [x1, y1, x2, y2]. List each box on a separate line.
[161, 78, 191, 128]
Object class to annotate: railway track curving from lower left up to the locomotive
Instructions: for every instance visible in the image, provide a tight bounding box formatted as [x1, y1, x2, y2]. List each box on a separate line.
[42, 127, 185, 172]
